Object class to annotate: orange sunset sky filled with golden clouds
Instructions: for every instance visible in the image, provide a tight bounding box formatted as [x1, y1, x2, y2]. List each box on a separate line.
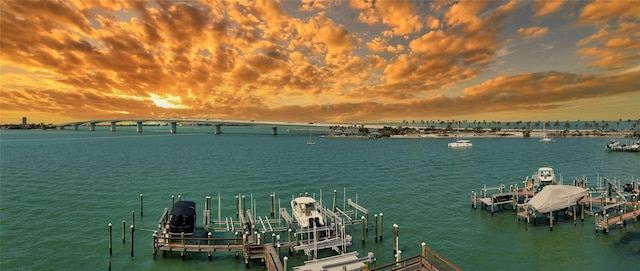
[0, 0, 640, 123]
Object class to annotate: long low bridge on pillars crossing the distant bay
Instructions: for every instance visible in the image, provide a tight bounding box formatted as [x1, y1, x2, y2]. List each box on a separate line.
[56, 118, 383, 135]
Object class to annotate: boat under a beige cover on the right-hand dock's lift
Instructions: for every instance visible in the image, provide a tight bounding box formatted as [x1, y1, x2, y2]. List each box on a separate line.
[528, 185, 587, 214]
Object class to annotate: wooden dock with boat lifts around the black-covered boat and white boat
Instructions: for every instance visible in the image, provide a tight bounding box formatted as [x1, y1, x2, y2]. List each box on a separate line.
[153, 191, 376, 270]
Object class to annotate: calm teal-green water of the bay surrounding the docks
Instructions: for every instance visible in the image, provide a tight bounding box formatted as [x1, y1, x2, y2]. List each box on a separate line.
[0, 127, 640, 270]
